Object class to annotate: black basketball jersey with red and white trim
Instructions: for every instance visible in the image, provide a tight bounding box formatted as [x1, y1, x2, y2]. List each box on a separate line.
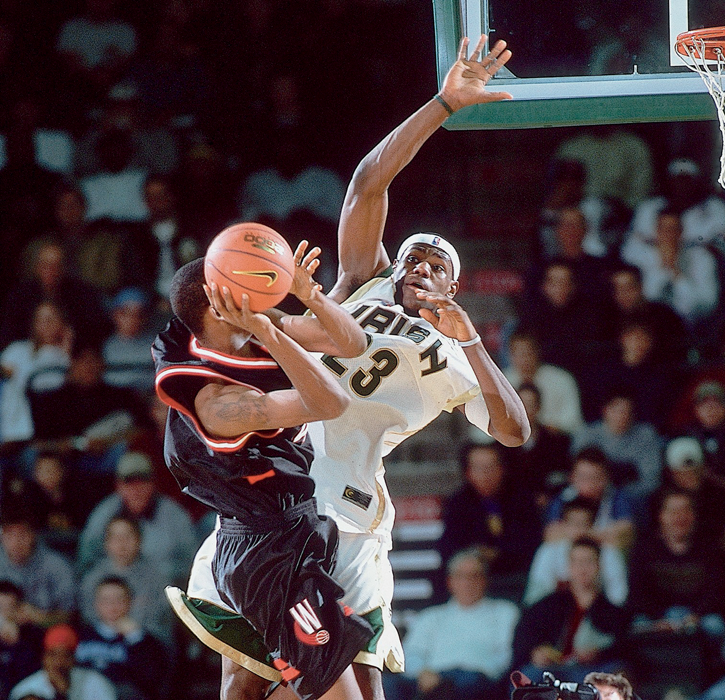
[152, 318, 314, 522]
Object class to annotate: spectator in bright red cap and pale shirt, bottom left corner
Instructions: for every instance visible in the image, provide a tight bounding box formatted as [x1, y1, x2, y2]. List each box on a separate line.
[10, 625, 117, 700]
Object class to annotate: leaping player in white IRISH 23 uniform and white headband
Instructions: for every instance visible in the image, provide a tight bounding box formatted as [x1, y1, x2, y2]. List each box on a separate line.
[170, 37, 529, 700]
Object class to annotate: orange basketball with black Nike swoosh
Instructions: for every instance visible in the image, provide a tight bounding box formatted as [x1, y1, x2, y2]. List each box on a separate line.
[204, 222, 295, 311]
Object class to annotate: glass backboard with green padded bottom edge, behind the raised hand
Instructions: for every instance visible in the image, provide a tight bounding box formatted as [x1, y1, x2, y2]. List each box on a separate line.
[433, 0, 725, 129]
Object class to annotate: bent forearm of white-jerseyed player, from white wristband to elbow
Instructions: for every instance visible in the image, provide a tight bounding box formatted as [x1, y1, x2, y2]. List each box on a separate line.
[464, 342, 531, 447]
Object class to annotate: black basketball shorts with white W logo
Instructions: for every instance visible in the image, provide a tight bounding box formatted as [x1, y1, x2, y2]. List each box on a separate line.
[212, 500, 373, 700]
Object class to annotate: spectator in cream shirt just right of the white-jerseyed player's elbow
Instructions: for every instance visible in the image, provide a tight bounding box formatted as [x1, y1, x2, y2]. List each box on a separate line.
[504, 331, 584, 434]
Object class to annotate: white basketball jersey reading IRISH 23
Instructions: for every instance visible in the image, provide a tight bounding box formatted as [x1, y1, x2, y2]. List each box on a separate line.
[309, 277, 490, 539]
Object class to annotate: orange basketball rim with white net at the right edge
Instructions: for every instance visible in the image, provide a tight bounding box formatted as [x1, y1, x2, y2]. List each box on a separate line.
[675, 27, 725, 188]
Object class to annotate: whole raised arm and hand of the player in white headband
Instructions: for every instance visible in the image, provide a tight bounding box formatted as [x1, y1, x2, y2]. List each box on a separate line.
[330, 36, 511, 301]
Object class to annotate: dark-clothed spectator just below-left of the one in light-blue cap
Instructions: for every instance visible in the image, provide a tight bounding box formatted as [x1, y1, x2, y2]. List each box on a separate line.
[33, 345, 148, 478]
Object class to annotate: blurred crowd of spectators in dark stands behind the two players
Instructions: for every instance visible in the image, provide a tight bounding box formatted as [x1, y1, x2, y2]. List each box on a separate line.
[0, 0, 725, 700]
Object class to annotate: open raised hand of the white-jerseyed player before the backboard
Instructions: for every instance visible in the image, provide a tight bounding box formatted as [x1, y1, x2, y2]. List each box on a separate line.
[440, 34, 513, 110]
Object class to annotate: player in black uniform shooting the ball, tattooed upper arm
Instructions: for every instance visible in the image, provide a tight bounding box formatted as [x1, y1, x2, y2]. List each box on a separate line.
[153, 244, 372, 700]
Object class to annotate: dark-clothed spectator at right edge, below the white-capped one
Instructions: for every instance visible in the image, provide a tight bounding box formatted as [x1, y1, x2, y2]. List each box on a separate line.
[629, 490, 725, 637]
